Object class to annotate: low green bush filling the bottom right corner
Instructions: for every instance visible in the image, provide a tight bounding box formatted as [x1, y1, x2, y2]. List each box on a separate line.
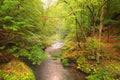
[87, 65, 120, 80]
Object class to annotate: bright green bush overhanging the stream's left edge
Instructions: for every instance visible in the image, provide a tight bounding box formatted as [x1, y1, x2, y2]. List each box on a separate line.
[14, 46, 47, 64]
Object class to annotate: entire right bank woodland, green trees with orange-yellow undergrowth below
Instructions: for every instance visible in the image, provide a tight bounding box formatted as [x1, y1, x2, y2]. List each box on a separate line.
[48, 0, 120, 80]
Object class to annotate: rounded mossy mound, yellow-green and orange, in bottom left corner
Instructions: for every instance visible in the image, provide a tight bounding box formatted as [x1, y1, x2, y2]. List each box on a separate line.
[0, 60, 35, 80]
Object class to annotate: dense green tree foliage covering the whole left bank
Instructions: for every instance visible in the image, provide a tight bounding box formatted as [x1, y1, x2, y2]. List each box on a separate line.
[0, 0, 47, 64]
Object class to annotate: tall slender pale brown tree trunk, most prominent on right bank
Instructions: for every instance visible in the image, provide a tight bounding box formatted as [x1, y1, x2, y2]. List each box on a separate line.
[96, 2, 105, 63]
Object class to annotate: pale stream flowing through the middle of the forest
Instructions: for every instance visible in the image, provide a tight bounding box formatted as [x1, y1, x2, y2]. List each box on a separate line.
[26, 42, 84, 80]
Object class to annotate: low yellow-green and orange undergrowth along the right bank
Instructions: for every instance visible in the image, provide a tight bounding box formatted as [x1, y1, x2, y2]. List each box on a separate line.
[62, 38, 120, 80]
